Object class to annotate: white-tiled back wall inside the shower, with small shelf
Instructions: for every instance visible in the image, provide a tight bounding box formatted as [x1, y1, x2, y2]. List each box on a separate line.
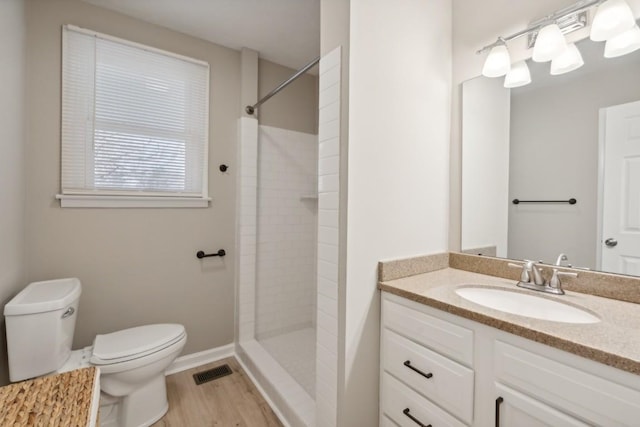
[255, 125, 318, 339]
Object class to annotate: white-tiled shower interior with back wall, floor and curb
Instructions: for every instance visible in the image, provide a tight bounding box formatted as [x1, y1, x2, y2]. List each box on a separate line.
[237, 118, 318, 426]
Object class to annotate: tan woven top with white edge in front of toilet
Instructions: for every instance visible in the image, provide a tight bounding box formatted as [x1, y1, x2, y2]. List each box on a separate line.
[0, 367, 100, 427]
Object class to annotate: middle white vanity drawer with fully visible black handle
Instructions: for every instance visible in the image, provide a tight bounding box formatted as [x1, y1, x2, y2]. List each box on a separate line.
[382, 329, 473, 424]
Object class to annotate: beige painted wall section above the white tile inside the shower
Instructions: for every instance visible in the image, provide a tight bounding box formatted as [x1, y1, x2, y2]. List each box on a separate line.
[258, 57, 318, 134]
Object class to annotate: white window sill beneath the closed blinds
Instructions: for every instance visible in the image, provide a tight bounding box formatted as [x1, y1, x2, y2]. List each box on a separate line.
[56, 194, 211, 208]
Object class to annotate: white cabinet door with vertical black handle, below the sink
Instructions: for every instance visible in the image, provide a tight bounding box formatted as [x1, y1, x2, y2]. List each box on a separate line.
[496, 384, 589, 427]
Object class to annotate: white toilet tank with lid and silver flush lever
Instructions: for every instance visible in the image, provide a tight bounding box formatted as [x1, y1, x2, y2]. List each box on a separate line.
[4, 278, 81, 382]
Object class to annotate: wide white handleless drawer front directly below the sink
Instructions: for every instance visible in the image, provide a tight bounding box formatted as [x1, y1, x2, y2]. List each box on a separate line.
[494, 341, 640, 427]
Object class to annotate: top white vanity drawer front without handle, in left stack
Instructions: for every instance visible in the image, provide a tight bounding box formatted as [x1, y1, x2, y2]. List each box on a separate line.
[382, 298, 473, 366]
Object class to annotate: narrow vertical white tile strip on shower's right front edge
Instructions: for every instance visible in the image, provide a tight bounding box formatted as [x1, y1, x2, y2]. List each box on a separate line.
[316, 48, 341, 427]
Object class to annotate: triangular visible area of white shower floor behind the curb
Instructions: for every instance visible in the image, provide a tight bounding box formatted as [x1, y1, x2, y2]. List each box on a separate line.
[259, 328, 316, 398]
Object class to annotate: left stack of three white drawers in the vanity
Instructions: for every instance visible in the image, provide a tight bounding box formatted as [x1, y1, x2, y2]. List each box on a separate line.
[380, 298, 474, 427]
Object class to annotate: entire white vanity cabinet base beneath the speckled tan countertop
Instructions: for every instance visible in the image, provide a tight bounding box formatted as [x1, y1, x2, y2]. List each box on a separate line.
[380, 292, 640, 427]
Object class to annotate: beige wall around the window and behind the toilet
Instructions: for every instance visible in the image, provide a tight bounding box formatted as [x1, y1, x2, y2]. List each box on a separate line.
[25, 0, 317, 362]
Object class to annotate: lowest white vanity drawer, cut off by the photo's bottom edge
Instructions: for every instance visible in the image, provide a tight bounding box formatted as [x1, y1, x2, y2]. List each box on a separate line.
[380, 372, 465, 427]
